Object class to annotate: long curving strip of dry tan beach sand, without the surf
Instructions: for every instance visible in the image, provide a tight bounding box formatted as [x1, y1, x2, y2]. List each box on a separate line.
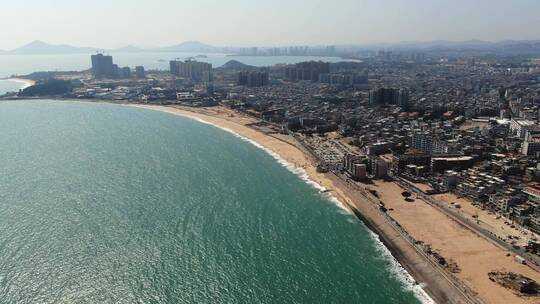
[132, 105, 494, 303]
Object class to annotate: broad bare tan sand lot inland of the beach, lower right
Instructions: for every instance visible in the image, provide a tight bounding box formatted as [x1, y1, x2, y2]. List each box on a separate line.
[369, 181, 540, 304]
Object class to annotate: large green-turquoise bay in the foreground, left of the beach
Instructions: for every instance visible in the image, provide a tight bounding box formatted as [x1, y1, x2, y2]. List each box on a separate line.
[0, 101, 419, 304]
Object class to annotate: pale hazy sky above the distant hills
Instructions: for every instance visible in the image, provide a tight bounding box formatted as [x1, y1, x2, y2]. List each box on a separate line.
[0, 0, 540, 49]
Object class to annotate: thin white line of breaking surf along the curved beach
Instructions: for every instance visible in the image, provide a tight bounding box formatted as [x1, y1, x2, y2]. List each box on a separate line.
[138, 107, 436, 304]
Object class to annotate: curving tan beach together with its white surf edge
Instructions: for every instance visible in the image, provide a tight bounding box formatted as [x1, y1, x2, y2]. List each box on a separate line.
[128, 104, 472, 303]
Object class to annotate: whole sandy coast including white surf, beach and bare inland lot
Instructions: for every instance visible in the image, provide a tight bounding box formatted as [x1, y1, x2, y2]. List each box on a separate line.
[6, 98, 540, 304]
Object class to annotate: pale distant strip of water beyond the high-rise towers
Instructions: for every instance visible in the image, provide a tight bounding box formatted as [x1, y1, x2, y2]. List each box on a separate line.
[0, 52, 350, 77]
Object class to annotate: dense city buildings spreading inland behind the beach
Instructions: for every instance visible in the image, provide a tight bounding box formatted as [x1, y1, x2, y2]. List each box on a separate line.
[8, 49, 540, 304]
